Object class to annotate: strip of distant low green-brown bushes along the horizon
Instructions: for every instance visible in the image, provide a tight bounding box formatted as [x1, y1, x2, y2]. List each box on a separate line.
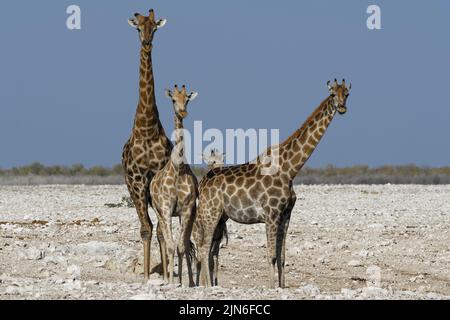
[0, 163, 450, 185]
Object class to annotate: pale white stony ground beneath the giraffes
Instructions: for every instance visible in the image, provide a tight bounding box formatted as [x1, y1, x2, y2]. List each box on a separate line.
[0, 185, 450, 299]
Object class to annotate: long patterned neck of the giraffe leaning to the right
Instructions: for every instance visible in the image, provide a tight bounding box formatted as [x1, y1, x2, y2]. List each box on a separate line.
[279, 96, 336, 180]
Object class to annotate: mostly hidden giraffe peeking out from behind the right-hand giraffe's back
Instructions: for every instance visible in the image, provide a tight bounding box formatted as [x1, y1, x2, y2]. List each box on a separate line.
[192, 149, 228, 286]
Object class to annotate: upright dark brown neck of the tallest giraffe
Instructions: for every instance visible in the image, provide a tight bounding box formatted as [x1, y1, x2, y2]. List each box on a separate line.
[133, 47, 162, 139]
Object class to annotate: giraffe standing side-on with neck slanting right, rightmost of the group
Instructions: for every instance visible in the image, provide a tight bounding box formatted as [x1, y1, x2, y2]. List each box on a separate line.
[195, 80, 351, 288]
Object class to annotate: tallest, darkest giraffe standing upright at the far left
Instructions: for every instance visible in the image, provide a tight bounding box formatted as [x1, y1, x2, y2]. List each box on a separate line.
[122, 9, 173, 280]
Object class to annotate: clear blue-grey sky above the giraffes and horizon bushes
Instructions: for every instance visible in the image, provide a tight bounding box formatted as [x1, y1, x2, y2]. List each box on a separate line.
[0, 0, 450, 168]
